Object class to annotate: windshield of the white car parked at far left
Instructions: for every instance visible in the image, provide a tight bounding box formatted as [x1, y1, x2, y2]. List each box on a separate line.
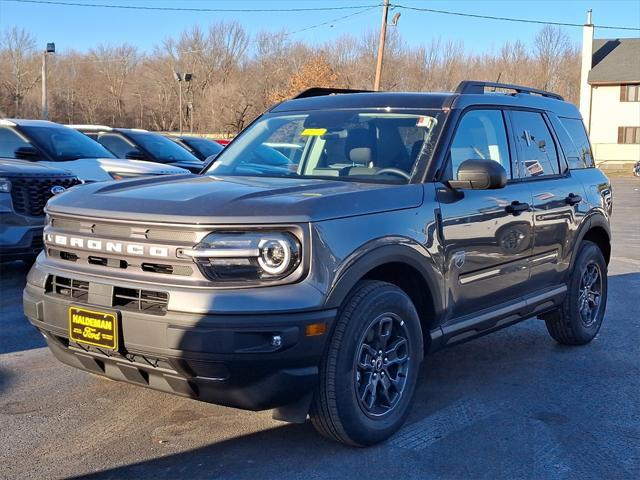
[20, 126, 115, 162]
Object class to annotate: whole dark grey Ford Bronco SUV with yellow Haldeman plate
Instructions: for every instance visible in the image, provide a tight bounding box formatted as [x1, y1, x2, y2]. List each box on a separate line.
[24, 81, 612, 446]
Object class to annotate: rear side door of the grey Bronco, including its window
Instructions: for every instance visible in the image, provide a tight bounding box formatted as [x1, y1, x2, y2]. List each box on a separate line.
[509, 110, 585, 291]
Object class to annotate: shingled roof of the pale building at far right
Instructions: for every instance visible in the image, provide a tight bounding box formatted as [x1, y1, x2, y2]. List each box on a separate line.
[588, 38, 640, 85]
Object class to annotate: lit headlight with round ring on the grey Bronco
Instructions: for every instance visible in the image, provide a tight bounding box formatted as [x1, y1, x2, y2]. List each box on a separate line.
[178, 231, 301, 282]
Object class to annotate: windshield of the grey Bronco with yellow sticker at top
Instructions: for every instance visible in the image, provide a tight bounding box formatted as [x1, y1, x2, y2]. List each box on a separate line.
[206, 109, 442, 183]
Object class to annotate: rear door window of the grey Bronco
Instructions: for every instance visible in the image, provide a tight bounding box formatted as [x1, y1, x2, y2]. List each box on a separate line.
[511, 111, 560, 178]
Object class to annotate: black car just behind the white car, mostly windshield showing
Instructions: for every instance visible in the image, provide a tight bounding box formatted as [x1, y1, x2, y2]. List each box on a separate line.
[68, 125, 203, 173]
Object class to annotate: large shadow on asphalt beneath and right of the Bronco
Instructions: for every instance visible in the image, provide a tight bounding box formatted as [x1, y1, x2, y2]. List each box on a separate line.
[77, 273, 640, 480]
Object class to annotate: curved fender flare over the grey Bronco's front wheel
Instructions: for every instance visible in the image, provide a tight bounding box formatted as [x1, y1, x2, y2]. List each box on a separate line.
[325, 237, 444, 315]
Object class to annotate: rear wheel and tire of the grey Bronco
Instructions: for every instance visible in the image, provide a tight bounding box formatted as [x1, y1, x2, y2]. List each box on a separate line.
[542, 241, 607, 345]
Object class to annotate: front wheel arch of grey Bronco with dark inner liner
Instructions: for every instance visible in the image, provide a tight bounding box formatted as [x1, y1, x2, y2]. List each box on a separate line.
[326, 245, 442, 353]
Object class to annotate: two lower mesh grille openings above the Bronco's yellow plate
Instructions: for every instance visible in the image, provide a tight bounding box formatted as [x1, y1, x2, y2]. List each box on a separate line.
[45, 275, 169, 315]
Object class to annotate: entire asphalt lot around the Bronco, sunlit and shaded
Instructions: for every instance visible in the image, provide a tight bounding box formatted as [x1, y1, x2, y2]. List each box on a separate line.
[0, 178, 640, 480]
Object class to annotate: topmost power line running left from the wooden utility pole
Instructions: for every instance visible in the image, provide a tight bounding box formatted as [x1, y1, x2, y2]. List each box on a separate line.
[4, 0, 382, 13]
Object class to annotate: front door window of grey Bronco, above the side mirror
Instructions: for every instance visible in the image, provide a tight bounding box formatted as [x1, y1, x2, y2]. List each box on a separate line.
[449, 110, 512, 180]
